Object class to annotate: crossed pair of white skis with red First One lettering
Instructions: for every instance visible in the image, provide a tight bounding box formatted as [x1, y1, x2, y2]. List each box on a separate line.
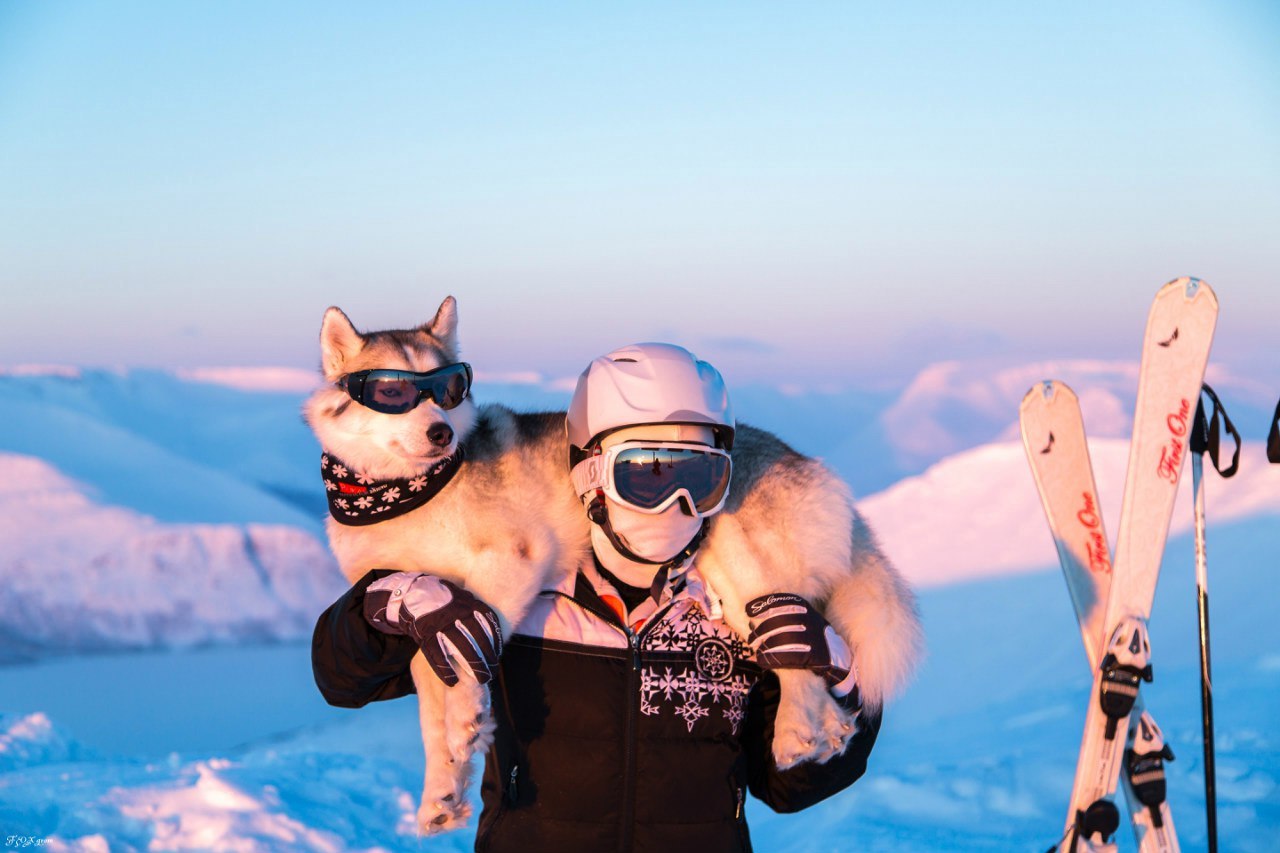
[1020, 278, 1217, 853]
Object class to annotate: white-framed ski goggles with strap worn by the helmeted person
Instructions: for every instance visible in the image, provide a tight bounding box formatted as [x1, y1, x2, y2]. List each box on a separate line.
[570, 442, 733, 515]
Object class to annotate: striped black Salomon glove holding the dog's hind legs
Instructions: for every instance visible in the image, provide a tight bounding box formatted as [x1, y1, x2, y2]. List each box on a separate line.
[746, 593, 856, 693]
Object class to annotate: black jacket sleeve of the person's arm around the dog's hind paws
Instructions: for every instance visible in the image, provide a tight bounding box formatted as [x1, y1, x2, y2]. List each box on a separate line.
[742, 672, 881, 812]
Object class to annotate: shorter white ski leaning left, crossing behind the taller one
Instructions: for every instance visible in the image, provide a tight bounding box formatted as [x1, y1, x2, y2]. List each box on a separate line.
[1019, 382, 1179, 853]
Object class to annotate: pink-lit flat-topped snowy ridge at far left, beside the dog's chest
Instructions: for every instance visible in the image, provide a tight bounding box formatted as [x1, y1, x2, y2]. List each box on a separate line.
[0, 453, 344, 653]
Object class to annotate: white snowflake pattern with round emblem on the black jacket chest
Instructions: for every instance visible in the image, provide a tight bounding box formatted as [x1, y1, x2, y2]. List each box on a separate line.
[640, 601, 759, 735]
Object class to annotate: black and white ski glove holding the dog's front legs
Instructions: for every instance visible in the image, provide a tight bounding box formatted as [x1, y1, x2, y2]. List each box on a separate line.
[365, 571, 502, 686]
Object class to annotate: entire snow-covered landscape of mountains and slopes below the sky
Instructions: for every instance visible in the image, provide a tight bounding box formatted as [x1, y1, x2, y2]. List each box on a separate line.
[0, 362, 1280, 853]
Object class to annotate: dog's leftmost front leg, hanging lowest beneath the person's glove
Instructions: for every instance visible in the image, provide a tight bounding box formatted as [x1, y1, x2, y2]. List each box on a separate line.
[410, 652, 471, 835]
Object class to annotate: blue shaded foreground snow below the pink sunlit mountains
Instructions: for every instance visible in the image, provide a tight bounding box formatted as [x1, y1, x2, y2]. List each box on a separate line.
[0, 507, 1280, 853]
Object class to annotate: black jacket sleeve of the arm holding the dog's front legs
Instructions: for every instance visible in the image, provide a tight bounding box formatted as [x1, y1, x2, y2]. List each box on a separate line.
[311, 569, 417, 708]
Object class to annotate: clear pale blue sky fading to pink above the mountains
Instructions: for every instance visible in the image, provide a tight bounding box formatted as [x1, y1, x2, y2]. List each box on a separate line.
[0, 0, 1280, 386]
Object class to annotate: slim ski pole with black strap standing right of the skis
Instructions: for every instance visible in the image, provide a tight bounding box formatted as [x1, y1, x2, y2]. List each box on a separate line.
[1190, 386, 1240, 853]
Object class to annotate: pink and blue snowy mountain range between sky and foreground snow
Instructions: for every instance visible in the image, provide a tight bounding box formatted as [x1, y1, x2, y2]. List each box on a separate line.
[0, 361, 1280, 658]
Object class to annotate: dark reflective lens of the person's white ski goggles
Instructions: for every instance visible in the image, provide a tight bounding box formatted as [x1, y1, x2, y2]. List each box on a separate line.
[613, 447, 730, 512]
